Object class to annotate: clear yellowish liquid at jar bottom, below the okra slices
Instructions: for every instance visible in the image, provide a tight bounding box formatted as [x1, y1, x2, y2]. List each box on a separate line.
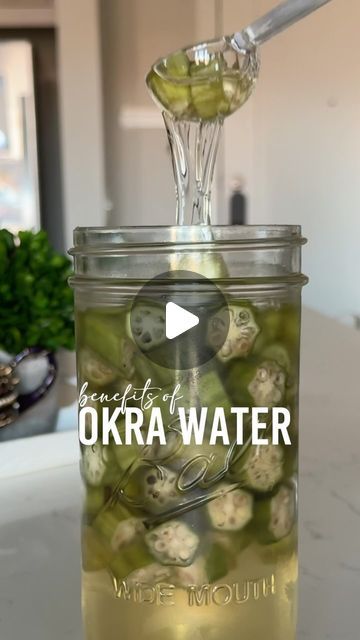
[83, 532, 298, 640]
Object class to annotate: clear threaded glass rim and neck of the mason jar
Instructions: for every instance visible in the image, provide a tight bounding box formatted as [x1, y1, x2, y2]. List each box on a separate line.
[69, 225, 307, 296]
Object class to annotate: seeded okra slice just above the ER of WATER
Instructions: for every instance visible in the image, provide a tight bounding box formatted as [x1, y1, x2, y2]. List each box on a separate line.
[248, 360, 286, 407]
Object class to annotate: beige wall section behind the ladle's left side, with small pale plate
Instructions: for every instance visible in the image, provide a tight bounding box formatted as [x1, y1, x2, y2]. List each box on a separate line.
[101, 0, 215, 225]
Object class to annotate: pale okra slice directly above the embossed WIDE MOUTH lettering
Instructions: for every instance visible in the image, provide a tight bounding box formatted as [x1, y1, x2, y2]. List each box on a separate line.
[145, 520, 199, 567]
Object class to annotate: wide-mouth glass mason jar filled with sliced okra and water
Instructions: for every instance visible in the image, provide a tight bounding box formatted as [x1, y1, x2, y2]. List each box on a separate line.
[71, 226, 306, 640]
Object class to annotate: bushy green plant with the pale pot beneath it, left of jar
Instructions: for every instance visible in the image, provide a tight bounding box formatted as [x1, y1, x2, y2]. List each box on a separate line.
[0, 229, 74, 440]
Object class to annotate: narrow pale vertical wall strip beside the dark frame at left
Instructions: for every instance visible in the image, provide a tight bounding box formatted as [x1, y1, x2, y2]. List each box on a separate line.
[55, 0, 106, 247]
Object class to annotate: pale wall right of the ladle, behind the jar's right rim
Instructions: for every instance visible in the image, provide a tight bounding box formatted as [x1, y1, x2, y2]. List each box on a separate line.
[223, 0, 360, 319]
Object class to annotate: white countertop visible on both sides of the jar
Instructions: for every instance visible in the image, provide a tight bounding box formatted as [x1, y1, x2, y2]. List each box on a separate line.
[0, 311, 360, 640]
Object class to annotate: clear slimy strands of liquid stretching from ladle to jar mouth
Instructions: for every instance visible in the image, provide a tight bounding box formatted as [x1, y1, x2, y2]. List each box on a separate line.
[163, 112, 223, 225]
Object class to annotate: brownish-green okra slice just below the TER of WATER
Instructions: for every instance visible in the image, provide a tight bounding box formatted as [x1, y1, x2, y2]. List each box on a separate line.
[228, 444, 284, 493]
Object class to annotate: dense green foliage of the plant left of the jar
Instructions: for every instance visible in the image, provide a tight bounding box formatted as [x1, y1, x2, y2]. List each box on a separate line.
[0, 229, 74, 353]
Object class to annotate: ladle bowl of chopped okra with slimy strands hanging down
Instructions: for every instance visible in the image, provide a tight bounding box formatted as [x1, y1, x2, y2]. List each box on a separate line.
[147, 39, 259, 226]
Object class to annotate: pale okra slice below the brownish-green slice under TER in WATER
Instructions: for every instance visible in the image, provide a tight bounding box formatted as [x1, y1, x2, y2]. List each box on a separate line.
[207, 484, 254, 531]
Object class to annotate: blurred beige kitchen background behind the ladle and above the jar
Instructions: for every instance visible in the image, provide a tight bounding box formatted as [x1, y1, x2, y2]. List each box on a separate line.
[0, 0, 360, 324]
